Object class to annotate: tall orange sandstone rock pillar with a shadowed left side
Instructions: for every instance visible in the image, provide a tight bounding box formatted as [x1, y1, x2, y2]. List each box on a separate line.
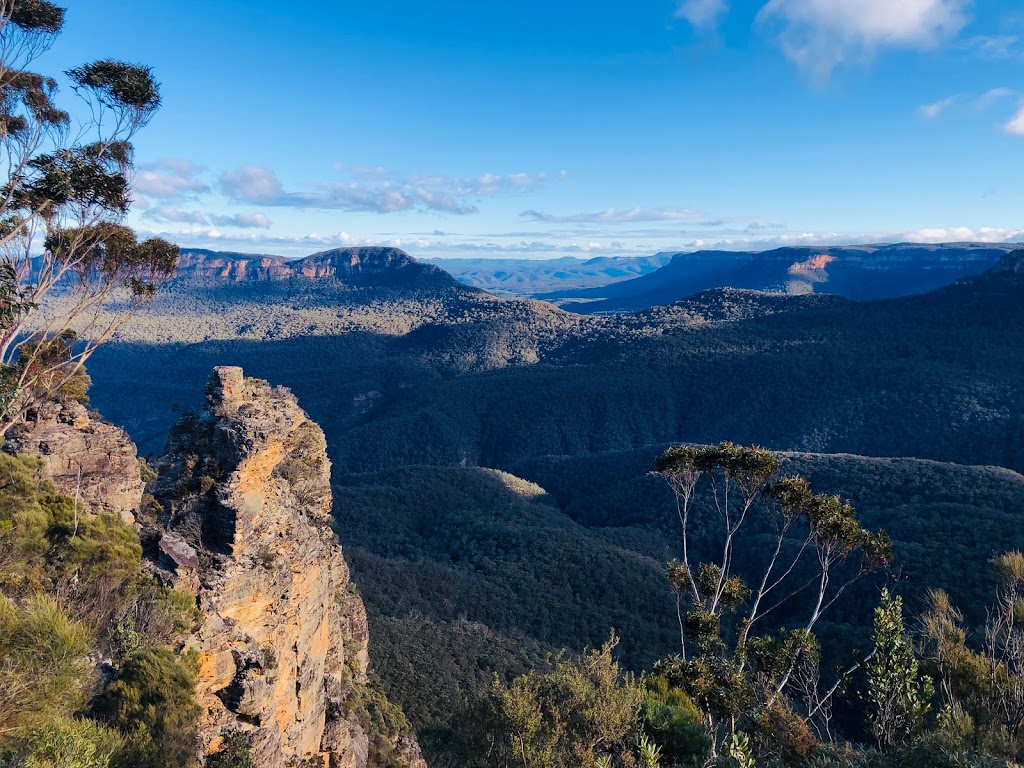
[143, 368, 423, 768]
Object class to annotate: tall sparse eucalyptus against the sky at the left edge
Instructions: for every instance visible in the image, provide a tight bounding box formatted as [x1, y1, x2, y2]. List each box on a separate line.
[0, 0, 178, 435]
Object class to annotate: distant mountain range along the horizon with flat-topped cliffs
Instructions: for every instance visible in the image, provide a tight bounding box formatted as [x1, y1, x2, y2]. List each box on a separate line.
[179, 243, 1020, 314]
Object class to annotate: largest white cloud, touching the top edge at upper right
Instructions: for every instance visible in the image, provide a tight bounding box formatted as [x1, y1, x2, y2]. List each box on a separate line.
[758, 0, 970, 78]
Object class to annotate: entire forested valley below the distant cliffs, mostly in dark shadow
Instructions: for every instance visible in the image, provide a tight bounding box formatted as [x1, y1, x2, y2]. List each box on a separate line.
[74, 249, 1024, 765]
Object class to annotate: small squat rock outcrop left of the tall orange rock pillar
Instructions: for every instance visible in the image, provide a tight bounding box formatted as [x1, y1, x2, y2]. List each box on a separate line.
[4, 400, 144, 522]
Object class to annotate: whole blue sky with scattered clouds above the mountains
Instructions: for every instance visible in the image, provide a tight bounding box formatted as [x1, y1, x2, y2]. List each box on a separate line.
[40, 0, 1024, 258]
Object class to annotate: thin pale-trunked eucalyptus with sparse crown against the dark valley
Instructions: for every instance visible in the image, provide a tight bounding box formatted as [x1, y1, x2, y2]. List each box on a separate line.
[657, 442, 891, 745]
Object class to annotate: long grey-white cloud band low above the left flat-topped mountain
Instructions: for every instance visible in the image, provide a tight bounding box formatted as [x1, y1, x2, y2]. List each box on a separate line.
[219, 165, 565, 215]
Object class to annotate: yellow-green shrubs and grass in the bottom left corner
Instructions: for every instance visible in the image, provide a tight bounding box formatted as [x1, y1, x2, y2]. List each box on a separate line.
[0, 454, 199, 768]
